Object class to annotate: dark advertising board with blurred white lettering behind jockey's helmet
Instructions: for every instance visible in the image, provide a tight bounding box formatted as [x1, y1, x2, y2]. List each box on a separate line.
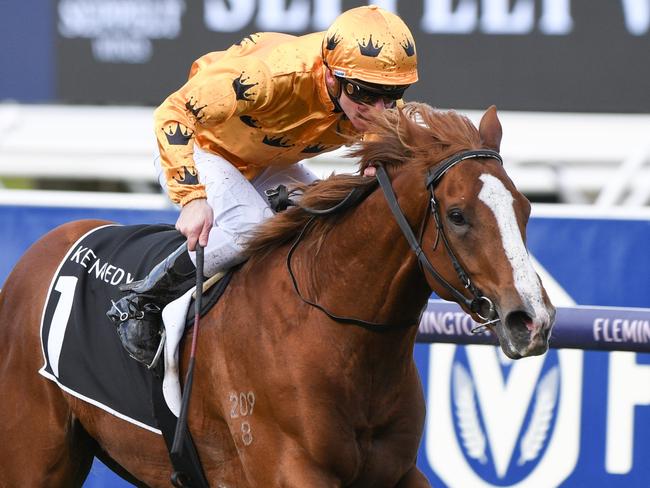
[0, 0, 650, 111]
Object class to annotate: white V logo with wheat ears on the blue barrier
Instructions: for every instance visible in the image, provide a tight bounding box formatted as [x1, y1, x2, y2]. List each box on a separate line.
[425, 344, 583, 486]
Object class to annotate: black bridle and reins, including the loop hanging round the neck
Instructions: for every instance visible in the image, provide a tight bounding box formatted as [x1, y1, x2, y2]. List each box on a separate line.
[287, 149, 503, 333]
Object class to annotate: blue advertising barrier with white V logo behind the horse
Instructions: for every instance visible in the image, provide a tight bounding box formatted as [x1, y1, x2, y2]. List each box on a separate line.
[0, 205, 650, 488]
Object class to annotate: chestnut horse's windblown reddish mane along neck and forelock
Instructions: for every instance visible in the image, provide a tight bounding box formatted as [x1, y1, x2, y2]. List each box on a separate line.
[245, 102, 481, 259]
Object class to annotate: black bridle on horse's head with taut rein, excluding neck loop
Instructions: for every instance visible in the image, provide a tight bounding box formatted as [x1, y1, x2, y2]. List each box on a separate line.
[377, 149, 503, 333]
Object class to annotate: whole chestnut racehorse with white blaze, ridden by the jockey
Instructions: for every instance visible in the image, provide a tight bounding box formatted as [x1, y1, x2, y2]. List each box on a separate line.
[0, 103, 555, 488]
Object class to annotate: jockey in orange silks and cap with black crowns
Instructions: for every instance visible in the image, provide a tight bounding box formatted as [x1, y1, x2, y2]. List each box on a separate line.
[109, 5, 418, 364]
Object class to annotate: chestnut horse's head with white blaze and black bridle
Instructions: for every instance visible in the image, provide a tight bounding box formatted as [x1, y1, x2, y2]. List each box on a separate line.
[359, 104, 555, 359]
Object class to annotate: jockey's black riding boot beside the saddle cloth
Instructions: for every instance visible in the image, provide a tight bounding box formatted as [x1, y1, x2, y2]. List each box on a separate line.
[106, 244, 196, 368]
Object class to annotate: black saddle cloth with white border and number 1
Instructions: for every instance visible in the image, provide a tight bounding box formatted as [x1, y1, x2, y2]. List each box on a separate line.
[40, 225, 184, 431]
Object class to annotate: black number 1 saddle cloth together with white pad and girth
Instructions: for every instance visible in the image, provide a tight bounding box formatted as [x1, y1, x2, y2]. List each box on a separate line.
[39, 225, 234, 486]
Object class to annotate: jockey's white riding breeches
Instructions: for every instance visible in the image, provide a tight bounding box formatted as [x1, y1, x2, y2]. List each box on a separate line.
[154, 146, 317, 276]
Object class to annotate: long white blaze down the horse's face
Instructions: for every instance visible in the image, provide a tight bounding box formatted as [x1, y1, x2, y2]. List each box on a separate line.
[478, 174, 549, 321]
